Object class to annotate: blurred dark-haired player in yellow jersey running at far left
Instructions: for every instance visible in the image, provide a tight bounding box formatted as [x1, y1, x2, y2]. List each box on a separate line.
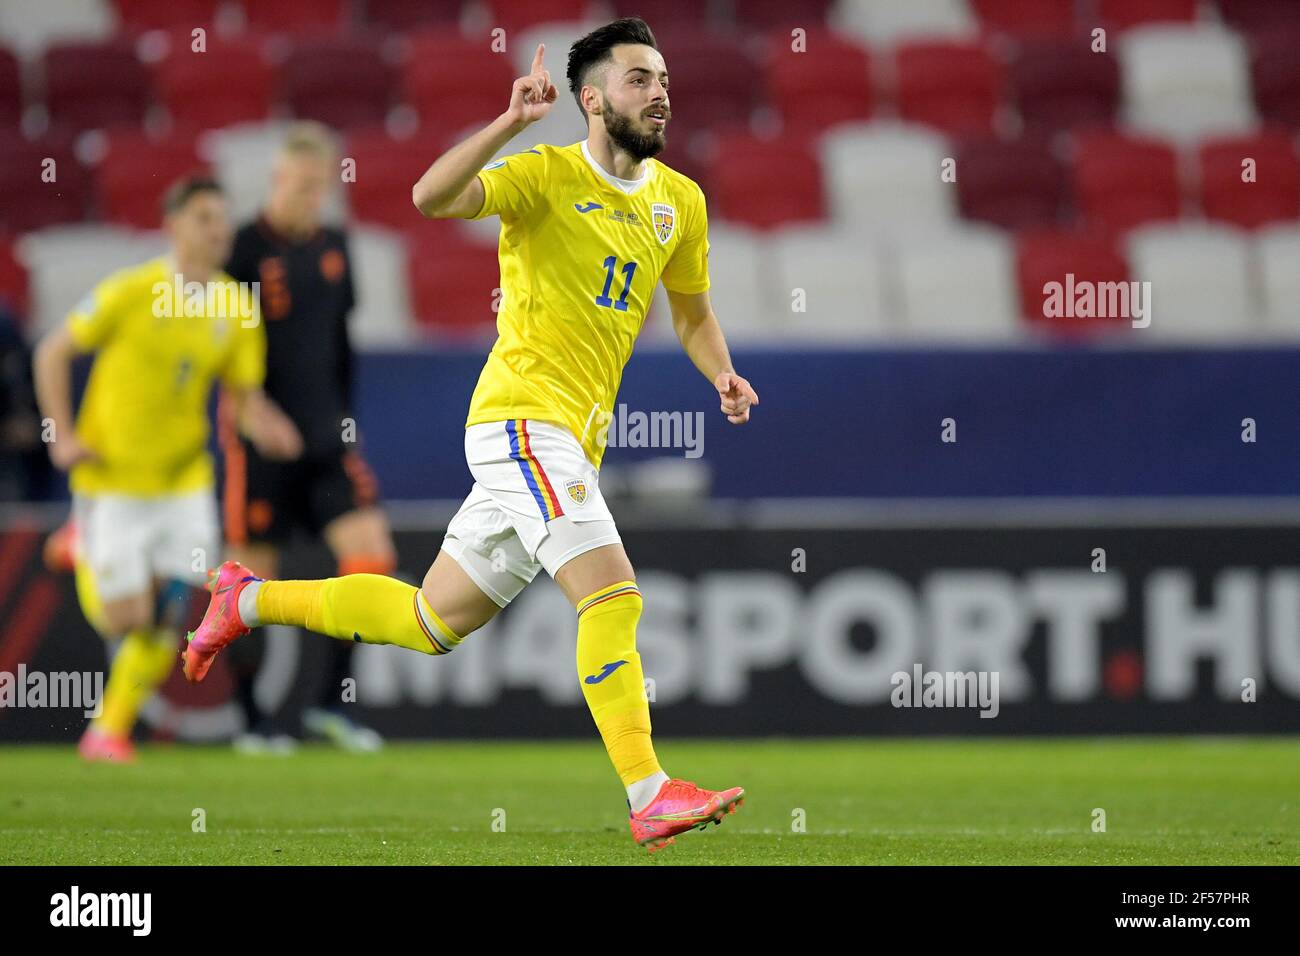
[34, 177, 302, 761]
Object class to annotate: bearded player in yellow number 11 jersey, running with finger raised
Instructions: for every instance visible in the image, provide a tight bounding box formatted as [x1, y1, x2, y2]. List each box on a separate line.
[186, 18, 758, 849]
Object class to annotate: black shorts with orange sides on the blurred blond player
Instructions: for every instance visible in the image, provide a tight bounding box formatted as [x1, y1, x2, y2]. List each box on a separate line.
[222, 441, 378, 545]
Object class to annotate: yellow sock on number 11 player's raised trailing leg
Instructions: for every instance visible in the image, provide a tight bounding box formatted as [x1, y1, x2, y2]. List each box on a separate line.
[250, 574, 462, 654]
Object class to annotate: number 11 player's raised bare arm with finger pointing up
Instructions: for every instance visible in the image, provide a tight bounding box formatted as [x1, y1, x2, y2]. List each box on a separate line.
[411, 44, 559, 219]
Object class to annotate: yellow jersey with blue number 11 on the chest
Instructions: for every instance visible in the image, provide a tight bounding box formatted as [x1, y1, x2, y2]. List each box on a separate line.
[465, 142, 709, 466]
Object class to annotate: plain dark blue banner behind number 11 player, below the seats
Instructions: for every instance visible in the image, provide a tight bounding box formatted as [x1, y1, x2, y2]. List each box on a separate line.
[358, 349, 1300, 498]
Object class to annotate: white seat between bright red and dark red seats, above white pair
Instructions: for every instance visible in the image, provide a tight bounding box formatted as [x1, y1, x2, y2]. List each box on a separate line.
[820, 122, 957, 233]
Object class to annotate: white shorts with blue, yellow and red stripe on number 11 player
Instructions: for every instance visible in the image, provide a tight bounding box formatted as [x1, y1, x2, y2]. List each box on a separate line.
[442, 419, 620, 607]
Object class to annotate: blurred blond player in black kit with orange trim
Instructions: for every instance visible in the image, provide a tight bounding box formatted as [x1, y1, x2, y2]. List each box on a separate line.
[222, 122, 397, 752]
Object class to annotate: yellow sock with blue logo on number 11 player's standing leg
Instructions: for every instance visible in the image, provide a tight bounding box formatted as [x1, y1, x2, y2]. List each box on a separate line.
[577, 581, 660, 787]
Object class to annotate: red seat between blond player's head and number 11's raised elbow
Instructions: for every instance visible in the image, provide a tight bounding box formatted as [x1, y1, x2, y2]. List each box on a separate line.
[343, 129, 447, 229]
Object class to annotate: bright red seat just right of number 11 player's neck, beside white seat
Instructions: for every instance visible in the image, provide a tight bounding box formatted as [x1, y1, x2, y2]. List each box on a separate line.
[709, 134, 826, 229]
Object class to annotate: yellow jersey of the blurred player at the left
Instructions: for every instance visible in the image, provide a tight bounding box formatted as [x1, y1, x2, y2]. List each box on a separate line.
[68, 258, 267, 496]
